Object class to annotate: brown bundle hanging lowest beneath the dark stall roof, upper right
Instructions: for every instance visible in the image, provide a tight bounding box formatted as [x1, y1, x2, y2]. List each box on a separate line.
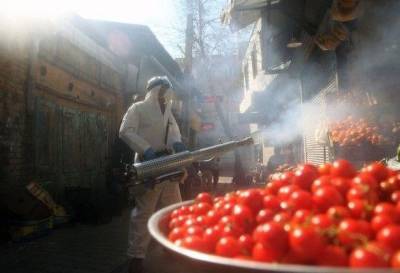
[315, 22, 349, 51]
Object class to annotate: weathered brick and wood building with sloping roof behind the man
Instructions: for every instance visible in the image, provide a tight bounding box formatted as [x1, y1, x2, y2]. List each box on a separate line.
[0, 17, 188, 204]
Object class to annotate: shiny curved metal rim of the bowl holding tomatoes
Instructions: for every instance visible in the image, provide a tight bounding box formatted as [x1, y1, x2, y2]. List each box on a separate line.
[147, 200, 399, 273]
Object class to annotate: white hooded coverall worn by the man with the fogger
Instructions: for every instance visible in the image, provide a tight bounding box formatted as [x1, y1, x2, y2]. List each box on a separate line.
[119, 86, 182, 258]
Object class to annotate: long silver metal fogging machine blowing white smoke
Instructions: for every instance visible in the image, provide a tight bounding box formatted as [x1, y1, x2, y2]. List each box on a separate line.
[126, 137, 254, 185]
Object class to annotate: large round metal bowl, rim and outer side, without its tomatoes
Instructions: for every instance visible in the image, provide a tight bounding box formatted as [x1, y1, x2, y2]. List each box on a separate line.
[148, 198, 398, 273]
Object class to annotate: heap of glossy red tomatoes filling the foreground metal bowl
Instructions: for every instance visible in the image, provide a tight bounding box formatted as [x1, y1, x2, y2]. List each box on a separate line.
[168, 160, 400, 268]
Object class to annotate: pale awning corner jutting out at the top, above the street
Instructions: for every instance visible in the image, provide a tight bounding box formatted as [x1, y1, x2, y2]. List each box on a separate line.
[221, 0, 280, 29]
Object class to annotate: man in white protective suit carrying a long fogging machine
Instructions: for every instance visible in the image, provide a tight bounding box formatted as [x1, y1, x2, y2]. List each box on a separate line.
[119, 76, 186, 273]
